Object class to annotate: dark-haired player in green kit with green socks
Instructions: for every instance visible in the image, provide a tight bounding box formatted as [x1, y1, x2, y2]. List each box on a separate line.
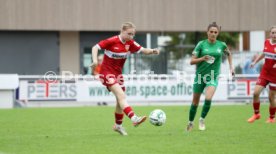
[187, 22, 234, 131]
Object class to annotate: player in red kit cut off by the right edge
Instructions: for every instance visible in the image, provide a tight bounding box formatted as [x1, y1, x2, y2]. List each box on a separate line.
[247, 26, 276, 123]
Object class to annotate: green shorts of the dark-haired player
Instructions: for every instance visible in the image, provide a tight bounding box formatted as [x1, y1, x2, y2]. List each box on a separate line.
[193, 76, 218, 93]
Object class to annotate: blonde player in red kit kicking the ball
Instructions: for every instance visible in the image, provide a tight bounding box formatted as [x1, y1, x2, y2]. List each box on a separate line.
[91, 22, 159, 135]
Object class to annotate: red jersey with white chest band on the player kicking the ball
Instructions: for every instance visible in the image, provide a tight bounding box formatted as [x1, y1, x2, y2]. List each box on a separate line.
[97, 35, 142, 75]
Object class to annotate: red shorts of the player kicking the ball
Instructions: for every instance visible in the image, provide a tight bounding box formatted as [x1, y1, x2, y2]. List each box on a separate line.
[99, 74, 126, 91]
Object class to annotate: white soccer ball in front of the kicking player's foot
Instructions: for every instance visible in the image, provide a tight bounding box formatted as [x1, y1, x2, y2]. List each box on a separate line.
[149, 109, 166, 126]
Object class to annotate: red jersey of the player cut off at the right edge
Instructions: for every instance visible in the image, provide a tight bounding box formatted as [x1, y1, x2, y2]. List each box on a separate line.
[260, 39, 276, 83]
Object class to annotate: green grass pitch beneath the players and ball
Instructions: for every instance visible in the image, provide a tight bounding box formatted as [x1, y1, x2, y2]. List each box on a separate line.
[0, 105, 276, 154]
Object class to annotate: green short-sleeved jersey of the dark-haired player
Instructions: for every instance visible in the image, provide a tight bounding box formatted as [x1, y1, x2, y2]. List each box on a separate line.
[193, 39, 227, 79]
